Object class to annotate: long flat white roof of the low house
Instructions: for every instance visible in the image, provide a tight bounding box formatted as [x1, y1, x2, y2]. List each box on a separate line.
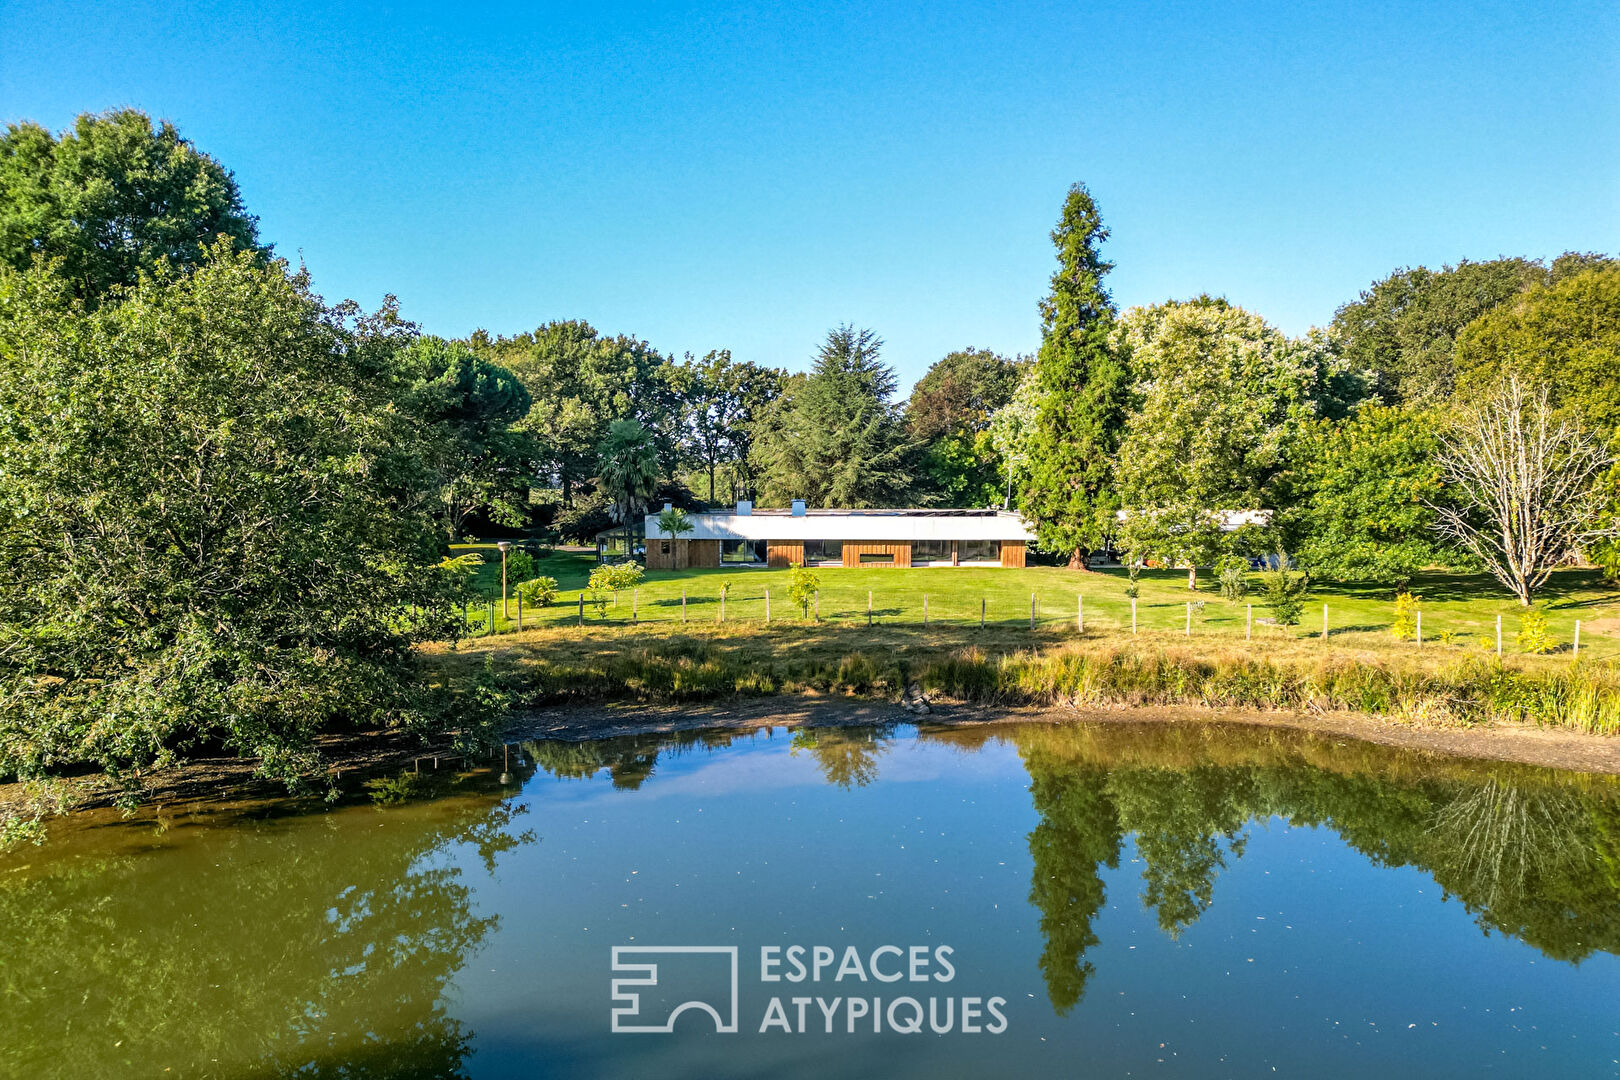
[646, 507, 1035, 542]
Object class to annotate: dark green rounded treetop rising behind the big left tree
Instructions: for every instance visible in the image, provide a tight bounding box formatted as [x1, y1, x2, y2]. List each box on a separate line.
[0, 108, 258, 304]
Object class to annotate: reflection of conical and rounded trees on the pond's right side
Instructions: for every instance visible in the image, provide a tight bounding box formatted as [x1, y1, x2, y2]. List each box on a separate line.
[959, 724, 1620, 1014]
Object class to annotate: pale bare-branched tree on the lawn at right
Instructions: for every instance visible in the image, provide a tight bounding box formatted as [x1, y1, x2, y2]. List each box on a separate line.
[1435, 377, 1614, 606]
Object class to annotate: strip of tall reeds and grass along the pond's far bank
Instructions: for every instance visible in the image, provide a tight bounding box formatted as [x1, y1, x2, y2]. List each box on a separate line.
[428, 623, 1620, 735]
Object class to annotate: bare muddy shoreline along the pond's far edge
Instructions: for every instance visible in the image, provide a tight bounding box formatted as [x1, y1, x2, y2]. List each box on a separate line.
[0, 696, 1620, 811]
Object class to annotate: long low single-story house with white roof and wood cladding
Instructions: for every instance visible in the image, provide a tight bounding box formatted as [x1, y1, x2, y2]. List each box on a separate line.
[646, 500, 1035, 570]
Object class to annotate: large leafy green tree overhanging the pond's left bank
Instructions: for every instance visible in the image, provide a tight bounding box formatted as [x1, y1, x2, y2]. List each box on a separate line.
[0, 241, 455, 793]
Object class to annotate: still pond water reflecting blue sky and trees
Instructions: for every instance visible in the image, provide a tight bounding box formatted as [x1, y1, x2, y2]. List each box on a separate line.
[0, 722, 1620, 1077]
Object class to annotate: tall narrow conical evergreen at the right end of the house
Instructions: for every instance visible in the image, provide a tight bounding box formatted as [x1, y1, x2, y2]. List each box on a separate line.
[1022, 185, 1126, 570]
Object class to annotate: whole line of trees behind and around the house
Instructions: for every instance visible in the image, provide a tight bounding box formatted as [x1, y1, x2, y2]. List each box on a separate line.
[0, 110, 1620, 803]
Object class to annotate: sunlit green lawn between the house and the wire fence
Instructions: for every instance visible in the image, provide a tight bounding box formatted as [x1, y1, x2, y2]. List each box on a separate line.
[450, 551, 1620, 659]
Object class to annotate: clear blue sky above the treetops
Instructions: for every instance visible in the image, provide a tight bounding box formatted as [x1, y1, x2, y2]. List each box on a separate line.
[0, 0, 1620, 384]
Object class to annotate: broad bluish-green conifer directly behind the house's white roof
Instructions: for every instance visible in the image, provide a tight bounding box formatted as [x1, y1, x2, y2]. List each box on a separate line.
[753, 325, 912, 507]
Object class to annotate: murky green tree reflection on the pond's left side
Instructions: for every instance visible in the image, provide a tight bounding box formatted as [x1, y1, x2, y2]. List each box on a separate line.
[0, 764, 533, 1080]
